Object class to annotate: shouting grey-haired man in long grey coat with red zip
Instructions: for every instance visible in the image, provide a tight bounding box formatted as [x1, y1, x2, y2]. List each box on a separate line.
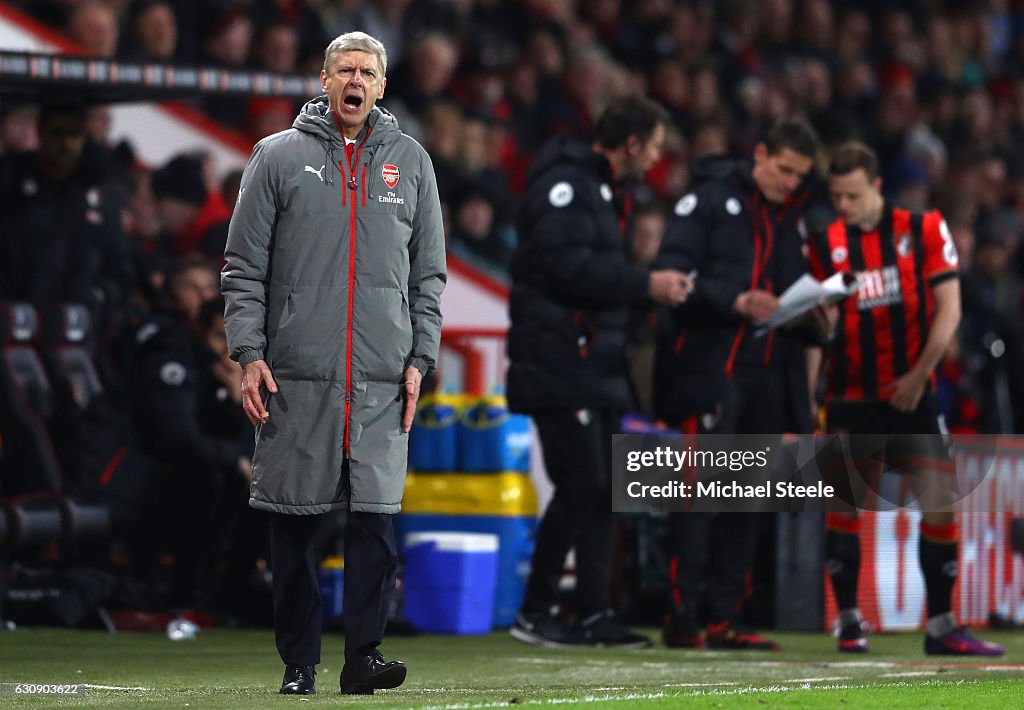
[221, 32, 446, 695]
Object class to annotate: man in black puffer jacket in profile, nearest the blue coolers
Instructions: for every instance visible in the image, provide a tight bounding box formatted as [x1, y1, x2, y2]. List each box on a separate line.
[508, 97, 689, 648]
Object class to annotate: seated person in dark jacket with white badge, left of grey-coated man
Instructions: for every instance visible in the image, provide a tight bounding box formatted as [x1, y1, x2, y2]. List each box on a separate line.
[129, 259, 252, 611]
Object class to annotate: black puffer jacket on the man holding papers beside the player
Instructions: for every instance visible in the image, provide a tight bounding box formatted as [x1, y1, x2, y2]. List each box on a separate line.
[654, 157, 812, 430]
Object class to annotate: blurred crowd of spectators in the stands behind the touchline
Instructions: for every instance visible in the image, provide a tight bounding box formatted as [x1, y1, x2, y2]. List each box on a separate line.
[0, 0, 1024, 618]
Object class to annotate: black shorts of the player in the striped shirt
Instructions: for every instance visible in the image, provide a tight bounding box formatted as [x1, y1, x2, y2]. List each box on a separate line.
[825, 392, 952, 471]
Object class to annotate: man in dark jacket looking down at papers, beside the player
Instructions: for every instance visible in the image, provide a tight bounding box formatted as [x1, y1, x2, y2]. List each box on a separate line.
[654, 119, 818, 651]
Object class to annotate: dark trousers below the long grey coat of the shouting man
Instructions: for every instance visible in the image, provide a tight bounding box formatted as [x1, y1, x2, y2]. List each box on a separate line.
[270, 512, 398, 666]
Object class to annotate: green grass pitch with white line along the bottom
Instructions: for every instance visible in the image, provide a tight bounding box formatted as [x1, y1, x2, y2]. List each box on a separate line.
[0, 628, 1024, 710]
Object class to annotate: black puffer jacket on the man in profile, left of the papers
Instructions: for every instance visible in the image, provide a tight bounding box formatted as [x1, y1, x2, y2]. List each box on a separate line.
[508, 139, 648, 412]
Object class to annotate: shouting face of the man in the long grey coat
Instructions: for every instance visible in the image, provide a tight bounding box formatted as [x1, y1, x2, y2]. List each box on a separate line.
[321, 51, 387, 138]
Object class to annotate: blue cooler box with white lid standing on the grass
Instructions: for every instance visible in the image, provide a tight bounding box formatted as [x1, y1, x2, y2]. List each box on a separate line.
[406, 532, 498, 634]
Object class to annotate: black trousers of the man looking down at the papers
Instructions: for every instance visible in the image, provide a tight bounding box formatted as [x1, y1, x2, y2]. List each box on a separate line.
[669, 368, 790, 622]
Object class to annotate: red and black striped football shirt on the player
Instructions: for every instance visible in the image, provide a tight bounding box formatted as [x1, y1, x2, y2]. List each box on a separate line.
[809, 203, 957, 400]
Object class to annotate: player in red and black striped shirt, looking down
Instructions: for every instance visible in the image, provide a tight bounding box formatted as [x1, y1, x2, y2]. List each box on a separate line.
[810, 142, 1002, 656]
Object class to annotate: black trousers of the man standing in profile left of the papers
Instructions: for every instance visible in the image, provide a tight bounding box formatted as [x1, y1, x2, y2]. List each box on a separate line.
[522, 410, 622, 617]
